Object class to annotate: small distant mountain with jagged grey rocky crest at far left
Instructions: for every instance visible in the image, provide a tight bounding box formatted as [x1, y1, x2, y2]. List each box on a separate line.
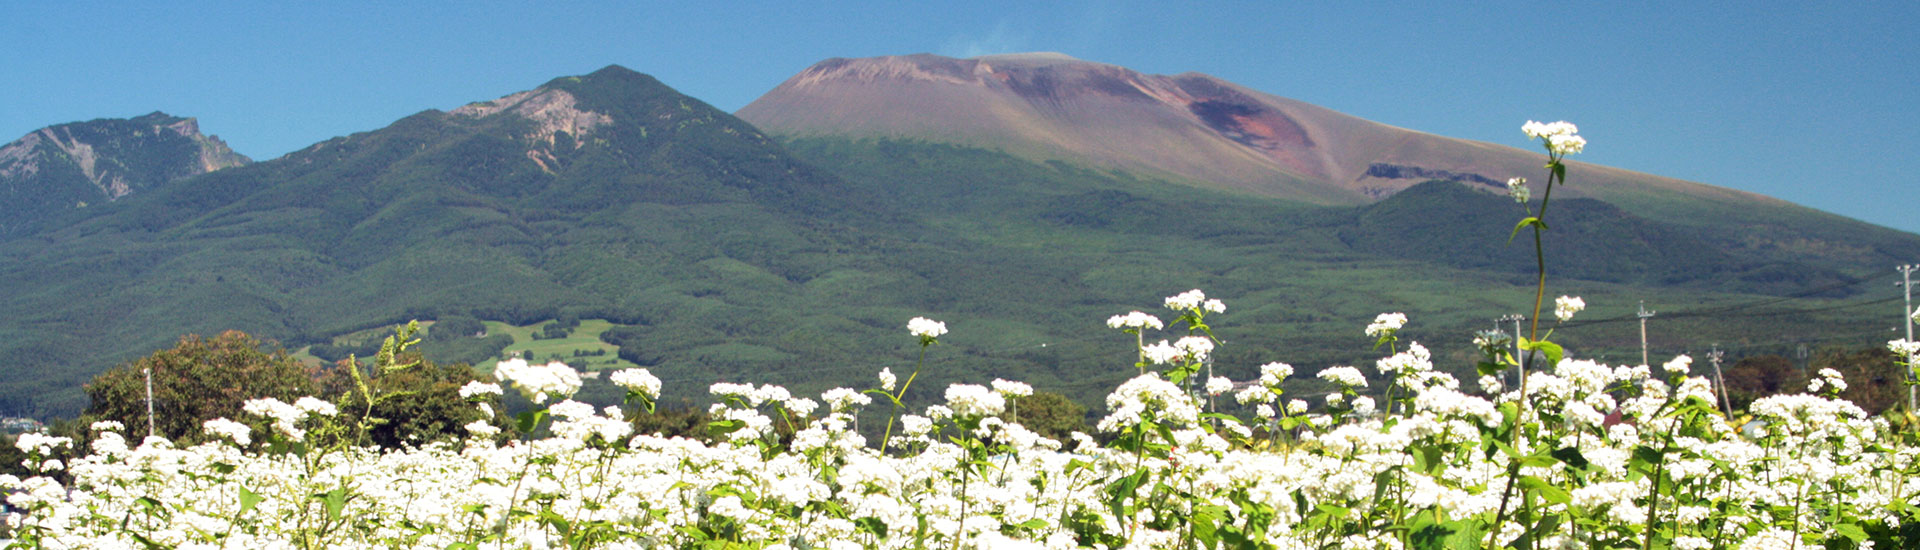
[0, 112, 250, 238]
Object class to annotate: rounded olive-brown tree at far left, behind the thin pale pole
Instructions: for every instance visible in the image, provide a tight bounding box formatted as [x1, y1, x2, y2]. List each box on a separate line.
[83, 331, 317, 442]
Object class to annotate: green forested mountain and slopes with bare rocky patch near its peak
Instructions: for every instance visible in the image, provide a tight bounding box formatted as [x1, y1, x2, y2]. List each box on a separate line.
[0, 67, 1920, 417]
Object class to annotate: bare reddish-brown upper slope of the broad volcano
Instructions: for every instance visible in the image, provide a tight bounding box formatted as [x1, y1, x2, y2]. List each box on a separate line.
[735, 54, 1789, 213]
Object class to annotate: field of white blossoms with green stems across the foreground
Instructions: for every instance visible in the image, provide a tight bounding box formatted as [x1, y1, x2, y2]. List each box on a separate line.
[0, 294, 1920, 548]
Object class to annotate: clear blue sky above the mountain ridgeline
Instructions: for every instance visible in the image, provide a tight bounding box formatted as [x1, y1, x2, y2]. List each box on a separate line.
[0, 0, 1920, 234]
